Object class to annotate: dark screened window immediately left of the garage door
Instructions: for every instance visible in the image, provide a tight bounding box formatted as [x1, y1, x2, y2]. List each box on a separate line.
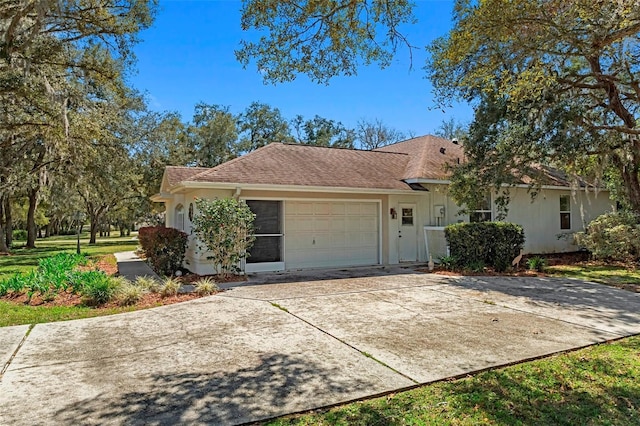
[247, 200, 283, 263]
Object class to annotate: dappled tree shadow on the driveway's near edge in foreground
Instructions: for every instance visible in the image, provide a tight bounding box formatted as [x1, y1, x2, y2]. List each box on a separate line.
[55, 354, 369, 425]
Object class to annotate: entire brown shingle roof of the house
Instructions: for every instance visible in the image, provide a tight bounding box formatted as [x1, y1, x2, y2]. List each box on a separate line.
[161, 136, 570, 190]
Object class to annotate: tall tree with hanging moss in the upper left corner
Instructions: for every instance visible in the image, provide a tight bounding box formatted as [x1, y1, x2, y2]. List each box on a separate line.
[0, 0, 156, 251]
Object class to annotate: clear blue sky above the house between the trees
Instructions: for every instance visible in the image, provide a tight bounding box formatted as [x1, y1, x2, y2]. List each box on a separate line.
[130, 0, 472, 135]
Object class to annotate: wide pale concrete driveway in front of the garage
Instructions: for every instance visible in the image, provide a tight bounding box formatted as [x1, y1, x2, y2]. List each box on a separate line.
[0, 269, 640, 425]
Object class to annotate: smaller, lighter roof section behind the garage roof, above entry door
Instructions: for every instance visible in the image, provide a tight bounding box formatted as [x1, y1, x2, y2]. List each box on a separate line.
[376, 135, 464, 180]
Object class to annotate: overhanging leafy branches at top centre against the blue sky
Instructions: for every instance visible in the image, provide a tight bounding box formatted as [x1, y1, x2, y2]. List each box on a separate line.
[236, 0, 415, 83]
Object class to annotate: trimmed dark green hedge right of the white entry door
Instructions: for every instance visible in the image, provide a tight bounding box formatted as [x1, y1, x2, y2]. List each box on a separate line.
[444, 222, 524, 272]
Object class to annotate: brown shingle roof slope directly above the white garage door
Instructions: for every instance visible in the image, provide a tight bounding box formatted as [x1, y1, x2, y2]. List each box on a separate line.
[189, 143, 410, 190]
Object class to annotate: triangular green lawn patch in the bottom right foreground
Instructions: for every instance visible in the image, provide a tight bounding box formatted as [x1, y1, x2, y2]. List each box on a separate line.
[266, 336, 640, 426]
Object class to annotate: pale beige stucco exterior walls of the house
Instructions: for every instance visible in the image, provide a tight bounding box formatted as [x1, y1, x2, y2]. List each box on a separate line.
[161, 184, 613, 274]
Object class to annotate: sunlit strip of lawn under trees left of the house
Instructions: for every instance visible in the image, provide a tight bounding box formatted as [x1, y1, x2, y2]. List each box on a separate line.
[0, 233, 138, 280]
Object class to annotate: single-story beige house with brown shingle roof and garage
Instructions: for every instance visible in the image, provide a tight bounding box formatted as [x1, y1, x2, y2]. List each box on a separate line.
[152, 136, 613, 274]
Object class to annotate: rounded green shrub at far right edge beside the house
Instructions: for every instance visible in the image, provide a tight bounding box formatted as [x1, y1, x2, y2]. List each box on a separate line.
[575, 212, 640, 261]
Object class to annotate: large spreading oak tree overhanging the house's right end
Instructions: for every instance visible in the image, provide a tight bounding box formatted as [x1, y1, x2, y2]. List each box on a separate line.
[427, 0, 640, 212]
